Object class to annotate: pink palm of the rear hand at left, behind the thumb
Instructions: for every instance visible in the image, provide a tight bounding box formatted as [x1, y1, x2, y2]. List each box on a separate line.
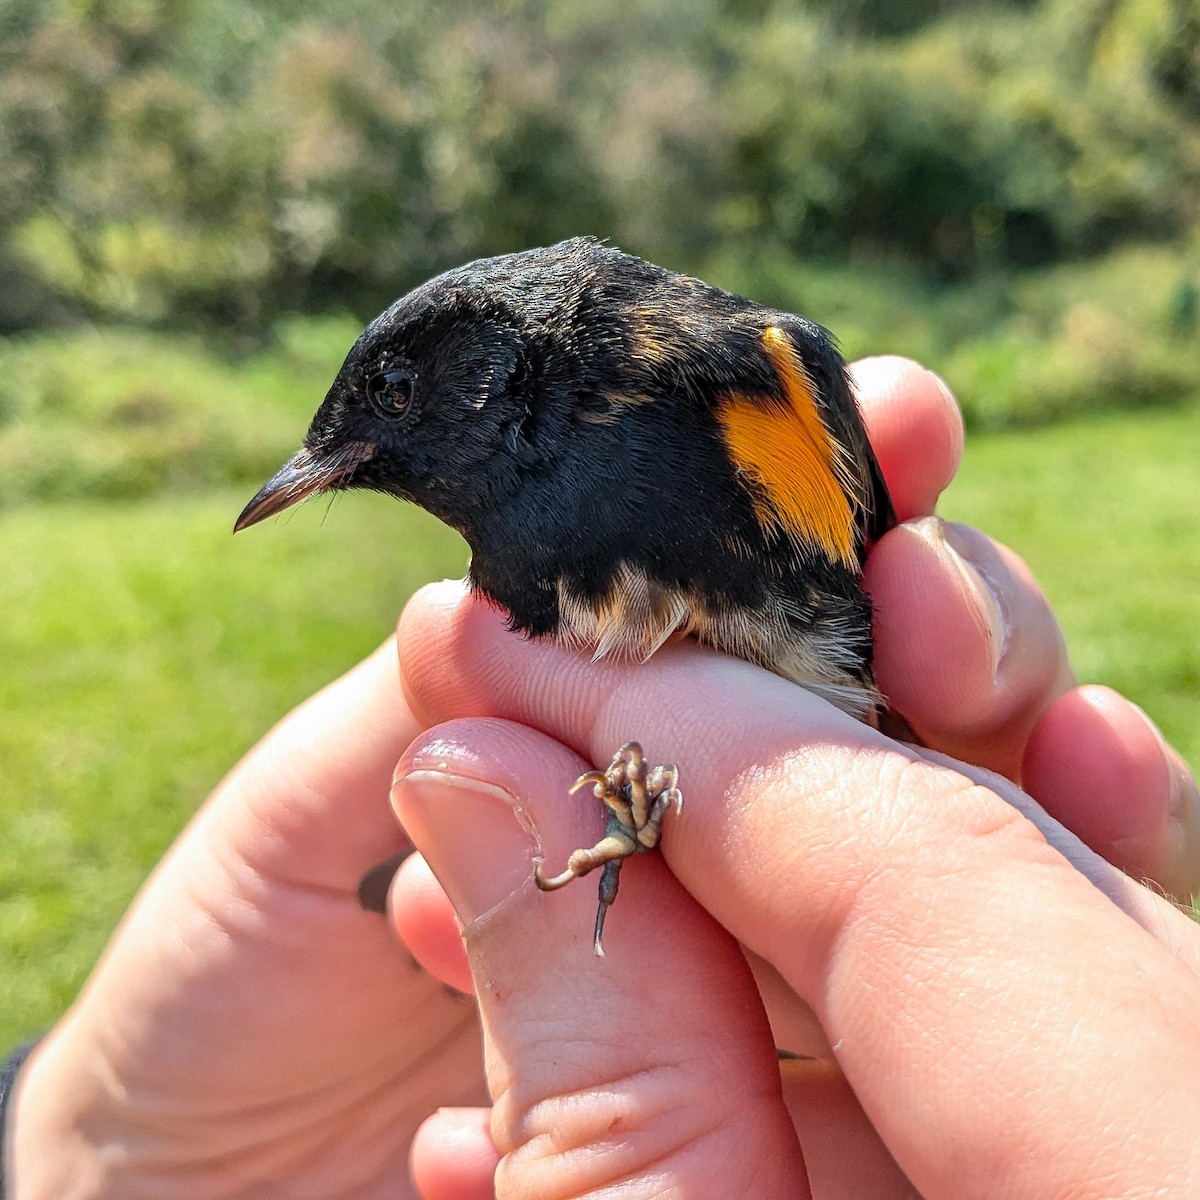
[10, 642, 486, 1200]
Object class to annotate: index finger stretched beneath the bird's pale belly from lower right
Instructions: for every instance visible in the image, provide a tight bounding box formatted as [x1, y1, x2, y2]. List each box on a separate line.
[400, 588, 1200, 1200]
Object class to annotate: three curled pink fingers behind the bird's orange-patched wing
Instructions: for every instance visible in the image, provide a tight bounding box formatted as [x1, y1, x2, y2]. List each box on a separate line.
[854, 358, 1200, 901]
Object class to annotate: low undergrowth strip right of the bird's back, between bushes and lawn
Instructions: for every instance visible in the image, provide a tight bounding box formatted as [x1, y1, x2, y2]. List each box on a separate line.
[706, 242, 1200, 430]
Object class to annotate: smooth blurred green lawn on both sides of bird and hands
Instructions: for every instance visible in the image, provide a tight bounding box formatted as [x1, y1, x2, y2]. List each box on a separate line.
[0, 402, 1200, 1045]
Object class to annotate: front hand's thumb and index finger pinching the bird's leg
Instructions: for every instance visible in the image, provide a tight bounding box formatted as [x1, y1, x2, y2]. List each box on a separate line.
[396, 592, 1200, 1200]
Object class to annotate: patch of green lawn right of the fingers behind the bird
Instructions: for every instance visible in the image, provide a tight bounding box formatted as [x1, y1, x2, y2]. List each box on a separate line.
[942, 403, 1200, 766]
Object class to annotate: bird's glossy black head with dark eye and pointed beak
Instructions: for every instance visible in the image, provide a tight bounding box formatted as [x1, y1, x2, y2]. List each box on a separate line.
[234, 240, 610, 538]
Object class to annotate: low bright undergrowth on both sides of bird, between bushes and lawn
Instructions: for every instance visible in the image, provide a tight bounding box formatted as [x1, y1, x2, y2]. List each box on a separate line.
[0, 238, 1200, 509]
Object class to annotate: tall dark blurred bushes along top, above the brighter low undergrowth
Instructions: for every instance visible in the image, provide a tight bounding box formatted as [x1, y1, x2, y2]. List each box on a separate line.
[0, 0, 1200, 334]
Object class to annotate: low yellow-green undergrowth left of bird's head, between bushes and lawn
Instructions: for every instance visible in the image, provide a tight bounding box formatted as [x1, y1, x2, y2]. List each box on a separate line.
[0, 318, 359, 508]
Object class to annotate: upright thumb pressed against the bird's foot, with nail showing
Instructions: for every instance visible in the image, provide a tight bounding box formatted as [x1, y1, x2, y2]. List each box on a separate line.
[394, 719, 808, 1200]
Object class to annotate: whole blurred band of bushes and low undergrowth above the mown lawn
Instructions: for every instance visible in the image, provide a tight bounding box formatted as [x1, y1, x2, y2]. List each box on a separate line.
[0, 0, 1200, 503]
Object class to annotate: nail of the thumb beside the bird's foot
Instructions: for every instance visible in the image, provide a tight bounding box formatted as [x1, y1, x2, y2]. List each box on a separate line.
[392, 768, 536, 926]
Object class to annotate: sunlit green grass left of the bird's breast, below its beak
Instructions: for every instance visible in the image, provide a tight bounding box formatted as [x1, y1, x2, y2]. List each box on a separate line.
[0, 492, 467, 1045]
